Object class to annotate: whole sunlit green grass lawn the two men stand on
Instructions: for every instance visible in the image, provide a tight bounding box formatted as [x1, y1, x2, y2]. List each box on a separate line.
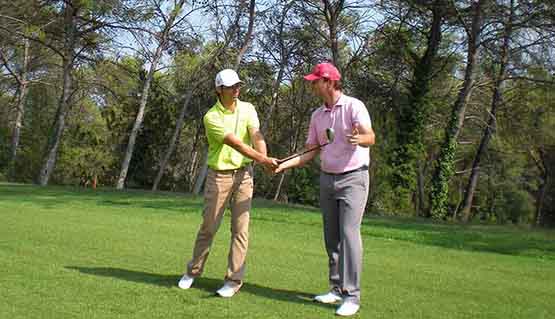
[0, 184, 555, 319]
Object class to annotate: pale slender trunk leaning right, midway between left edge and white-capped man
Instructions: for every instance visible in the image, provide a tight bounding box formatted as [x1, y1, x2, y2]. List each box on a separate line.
[116, 0, 185, 189]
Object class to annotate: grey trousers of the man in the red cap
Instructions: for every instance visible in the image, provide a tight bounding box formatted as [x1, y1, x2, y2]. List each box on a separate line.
[320, 170, 369, 303]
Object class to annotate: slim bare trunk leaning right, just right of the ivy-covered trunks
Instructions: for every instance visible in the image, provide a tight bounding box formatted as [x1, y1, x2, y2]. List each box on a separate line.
[459, 0, 515, 223]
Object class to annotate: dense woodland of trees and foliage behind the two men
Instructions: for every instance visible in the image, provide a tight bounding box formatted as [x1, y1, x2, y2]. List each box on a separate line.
[0, 0, 555, 226]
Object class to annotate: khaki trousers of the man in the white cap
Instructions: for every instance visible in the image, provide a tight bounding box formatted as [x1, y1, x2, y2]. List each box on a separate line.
[187, 165, 253, 284]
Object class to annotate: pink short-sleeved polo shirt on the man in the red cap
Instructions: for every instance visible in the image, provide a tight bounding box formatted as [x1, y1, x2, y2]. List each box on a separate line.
[306, 94, 372, 174]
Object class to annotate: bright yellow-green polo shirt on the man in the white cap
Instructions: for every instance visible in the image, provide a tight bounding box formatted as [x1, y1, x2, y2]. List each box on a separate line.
[204, 100, 260, 170]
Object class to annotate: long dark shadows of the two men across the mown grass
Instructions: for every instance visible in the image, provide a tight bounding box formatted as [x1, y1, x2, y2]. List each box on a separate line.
[65, 266, 335, 308]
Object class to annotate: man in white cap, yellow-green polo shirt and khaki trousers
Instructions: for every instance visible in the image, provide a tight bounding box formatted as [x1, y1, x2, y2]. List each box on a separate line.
[178, 69, 277, 297]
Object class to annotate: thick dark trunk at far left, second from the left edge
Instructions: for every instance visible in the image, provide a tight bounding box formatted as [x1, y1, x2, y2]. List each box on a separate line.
[38, 3, 78, 186]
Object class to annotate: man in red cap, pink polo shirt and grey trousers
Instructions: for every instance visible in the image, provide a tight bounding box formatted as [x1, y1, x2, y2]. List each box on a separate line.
[275, 63, 375, 316]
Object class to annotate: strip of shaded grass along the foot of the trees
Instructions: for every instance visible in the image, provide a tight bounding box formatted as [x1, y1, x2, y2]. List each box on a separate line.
[5, 183, 555, 260]
